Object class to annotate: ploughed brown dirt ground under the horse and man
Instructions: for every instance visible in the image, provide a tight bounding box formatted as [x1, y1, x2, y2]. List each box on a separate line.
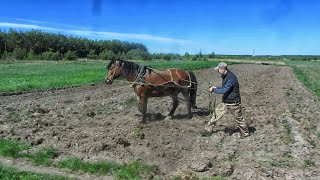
[0, 64, 320, 179]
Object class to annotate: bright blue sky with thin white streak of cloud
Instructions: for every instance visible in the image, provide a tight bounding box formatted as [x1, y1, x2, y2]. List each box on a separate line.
[0, 0, 320, 55]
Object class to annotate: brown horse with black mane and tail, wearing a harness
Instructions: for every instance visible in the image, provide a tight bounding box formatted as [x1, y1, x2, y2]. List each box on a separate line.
[105, 60, 197, 123]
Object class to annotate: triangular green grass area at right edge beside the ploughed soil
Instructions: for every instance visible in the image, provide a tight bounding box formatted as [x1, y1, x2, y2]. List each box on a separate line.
[286, 61, 320, 96]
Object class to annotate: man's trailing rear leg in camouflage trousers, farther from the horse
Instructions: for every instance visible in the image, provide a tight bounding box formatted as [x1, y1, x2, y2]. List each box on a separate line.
[228, 104, 250, 137]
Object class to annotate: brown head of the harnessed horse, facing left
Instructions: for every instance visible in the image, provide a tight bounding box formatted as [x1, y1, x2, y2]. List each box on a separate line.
[105, 59, 123, 84]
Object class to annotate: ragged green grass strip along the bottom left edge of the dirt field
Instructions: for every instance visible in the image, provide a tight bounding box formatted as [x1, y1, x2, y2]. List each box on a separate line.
[0, 139, 155, 179]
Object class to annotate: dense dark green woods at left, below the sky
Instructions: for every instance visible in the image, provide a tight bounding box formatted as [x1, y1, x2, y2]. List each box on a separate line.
[0, 29, 159, 60]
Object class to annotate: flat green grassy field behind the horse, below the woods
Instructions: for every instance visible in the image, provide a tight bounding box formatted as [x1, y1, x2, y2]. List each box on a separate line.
[0, 61, 216, 92]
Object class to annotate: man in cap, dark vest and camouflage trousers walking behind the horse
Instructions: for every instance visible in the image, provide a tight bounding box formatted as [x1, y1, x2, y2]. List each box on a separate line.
[202, 62, 250, 138]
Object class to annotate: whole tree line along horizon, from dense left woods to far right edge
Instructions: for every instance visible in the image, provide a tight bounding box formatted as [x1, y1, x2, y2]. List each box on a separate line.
[0, 29, 320, 61]
